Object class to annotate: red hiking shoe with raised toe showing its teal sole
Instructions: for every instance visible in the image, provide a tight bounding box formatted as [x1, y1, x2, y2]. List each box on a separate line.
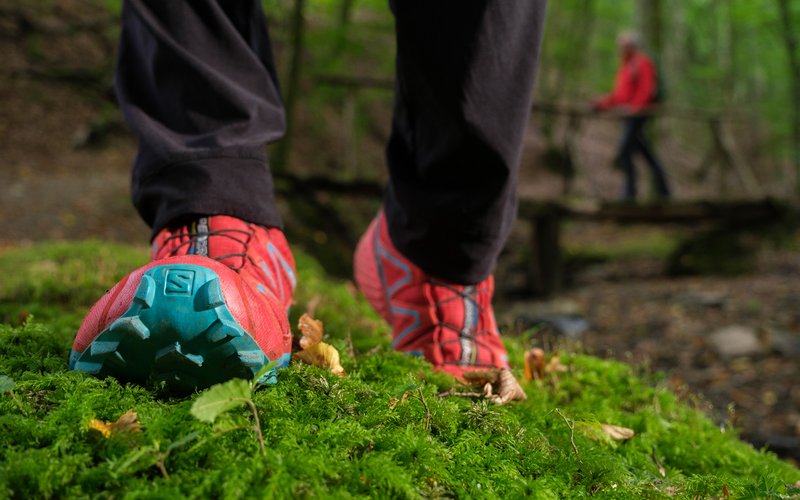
[69, 215, 295, 391]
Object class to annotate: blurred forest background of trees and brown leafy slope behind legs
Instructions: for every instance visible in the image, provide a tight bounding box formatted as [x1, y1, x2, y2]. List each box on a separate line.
[0, 0, 800, 458]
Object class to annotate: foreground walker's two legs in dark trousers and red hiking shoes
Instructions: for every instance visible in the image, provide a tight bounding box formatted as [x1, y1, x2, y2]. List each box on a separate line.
[70, 0, 546, 398]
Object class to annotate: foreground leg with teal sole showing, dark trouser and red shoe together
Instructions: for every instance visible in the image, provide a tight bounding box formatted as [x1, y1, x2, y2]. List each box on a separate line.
[69, 0, 295, 391]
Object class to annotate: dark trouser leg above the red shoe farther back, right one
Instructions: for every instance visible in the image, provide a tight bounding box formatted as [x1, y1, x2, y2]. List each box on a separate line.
[385, 0, 546, 284]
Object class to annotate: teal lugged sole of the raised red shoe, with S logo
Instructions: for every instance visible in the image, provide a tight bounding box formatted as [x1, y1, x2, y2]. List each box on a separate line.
[69, 264, 291, 392]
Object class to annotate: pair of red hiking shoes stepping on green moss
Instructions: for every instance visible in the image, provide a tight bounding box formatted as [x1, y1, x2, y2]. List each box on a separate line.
[69, 214, 508, 391]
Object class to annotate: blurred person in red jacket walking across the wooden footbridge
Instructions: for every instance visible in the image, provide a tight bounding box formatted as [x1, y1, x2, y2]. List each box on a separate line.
[593, 33, 670, 201]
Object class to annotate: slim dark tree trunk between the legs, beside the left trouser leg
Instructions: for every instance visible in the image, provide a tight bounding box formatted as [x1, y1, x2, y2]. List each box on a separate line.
[271, 0, 306, 172]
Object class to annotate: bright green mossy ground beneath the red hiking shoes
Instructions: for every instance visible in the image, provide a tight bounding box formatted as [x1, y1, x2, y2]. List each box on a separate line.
[0, 242, 800, 498]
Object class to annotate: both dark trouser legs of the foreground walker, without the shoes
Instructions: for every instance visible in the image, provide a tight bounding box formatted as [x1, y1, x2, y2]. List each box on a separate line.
[116, 0, 546, 284]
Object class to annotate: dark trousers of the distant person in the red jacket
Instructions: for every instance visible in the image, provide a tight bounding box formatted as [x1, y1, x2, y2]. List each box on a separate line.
[617, 115, 670, 200]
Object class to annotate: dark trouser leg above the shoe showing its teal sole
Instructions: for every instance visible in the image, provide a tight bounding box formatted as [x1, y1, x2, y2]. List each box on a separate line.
[116, 0, 284, 235]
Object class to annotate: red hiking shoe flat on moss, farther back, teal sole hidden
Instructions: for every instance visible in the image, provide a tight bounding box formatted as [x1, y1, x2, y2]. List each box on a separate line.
[354, 212, 509, 377]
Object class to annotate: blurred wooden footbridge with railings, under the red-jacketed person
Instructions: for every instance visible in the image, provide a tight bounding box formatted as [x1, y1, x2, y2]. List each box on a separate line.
[282, 75, 798, 295]
